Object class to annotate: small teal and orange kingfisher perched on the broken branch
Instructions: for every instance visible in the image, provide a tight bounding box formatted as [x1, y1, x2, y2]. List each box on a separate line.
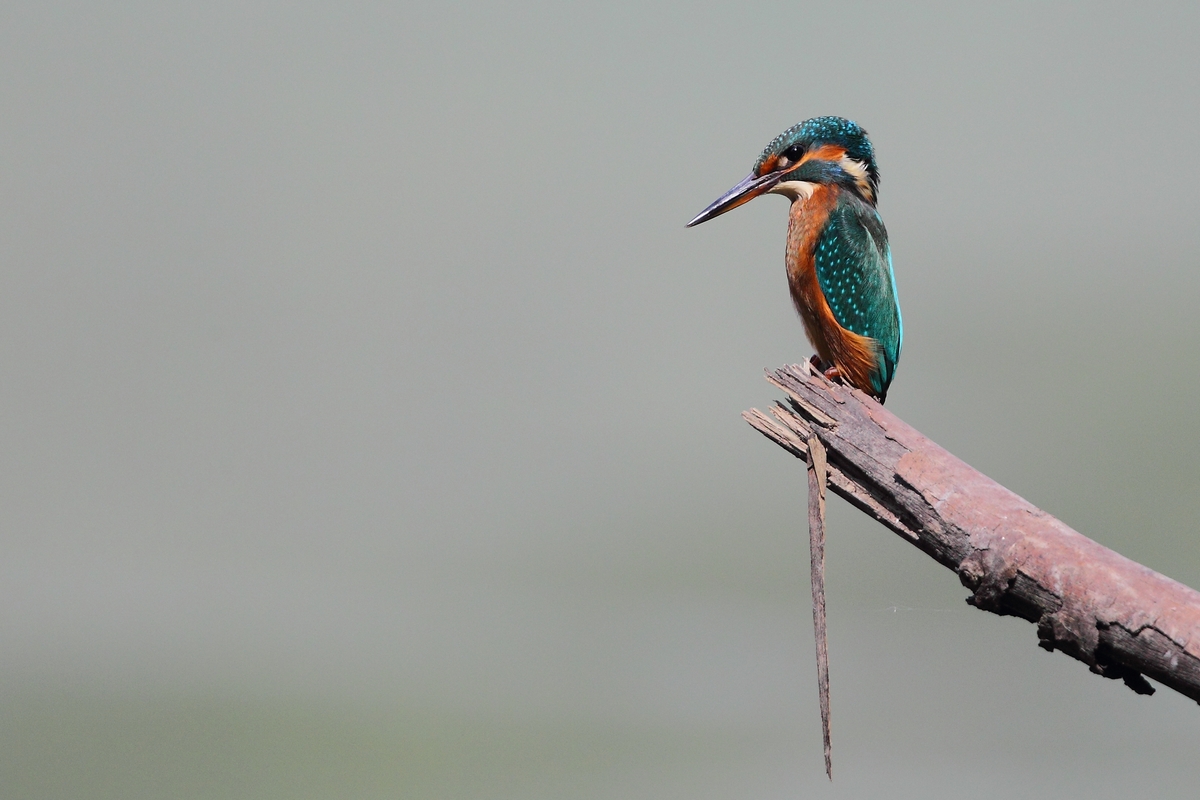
[688, 116, 904, 403]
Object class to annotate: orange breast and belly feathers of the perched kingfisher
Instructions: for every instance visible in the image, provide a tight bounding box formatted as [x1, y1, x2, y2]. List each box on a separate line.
[787, 186, 878, 395]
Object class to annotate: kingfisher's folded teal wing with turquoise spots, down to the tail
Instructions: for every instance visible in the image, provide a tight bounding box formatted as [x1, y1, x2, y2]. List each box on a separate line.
[814, 193, 904, 396]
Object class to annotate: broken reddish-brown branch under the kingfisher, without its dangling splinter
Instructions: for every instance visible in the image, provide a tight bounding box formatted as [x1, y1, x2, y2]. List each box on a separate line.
[743, 363, 1200, 702]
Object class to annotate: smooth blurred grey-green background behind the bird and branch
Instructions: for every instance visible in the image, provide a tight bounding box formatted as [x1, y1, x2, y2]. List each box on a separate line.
[0, 2, 1200, 800]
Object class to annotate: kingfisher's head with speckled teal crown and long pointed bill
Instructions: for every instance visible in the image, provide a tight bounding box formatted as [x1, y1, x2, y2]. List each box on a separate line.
[688, 116, 880, 228]
